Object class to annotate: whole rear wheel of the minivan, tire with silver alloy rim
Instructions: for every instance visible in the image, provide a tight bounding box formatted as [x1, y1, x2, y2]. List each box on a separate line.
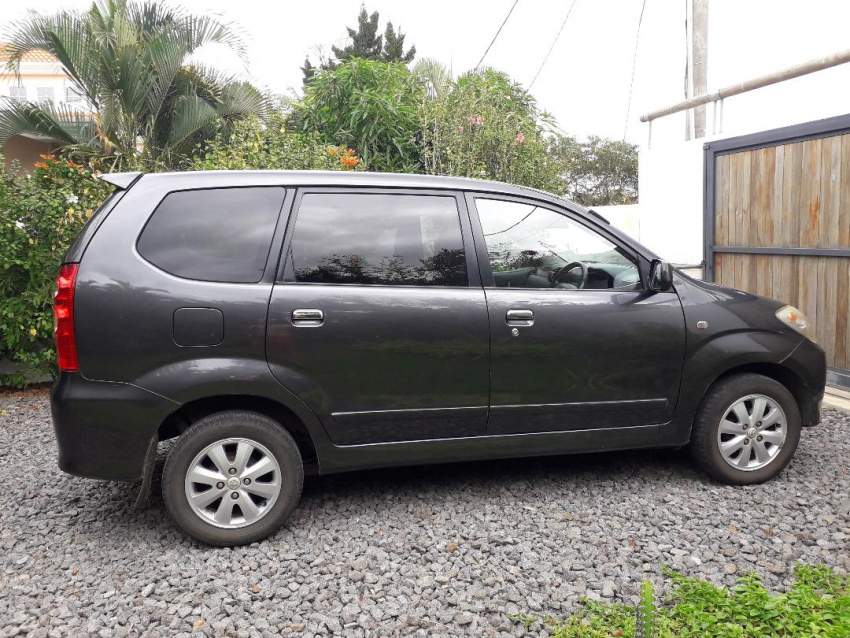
[162, 410, 304, 545]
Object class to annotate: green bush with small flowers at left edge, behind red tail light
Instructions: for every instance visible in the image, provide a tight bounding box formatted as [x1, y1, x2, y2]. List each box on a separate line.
[0, 156, 110, 385]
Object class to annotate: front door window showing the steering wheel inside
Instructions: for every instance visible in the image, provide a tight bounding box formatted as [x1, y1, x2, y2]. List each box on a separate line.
[475, 197, 640, 290]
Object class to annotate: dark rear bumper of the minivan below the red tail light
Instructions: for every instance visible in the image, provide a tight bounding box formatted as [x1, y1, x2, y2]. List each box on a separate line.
[50, 373, 178, 480]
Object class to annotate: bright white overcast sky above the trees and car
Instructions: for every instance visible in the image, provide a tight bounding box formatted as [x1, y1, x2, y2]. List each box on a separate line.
[0, 0, 850, 143]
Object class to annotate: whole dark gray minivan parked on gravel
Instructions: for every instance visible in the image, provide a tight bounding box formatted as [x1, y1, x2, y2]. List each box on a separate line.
[52, 171, 825, 545]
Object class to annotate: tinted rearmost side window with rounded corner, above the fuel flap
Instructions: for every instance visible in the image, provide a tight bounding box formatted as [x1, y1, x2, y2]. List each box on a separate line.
[138, 187, 284, 283]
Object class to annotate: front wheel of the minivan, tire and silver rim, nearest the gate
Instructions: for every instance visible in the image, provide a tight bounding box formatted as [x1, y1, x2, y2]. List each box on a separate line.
[691, 374, 801, 485]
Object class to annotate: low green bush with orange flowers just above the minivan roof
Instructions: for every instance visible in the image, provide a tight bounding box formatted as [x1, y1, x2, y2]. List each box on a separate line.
[191, 112, 360, 170]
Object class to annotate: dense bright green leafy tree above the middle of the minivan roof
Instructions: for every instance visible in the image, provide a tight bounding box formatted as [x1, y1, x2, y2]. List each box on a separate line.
[297, 58, 425, 172]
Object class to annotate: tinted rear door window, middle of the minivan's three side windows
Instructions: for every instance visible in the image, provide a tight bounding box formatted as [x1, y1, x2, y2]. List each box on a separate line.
[286, 193, 467, 286]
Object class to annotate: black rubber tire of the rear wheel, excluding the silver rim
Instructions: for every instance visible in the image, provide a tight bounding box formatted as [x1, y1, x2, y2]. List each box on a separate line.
[162, 410, 304, 546]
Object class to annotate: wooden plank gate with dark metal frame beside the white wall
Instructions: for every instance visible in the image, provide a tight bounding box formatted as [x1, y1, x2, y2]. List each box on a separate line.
[704, 115, 850, 385]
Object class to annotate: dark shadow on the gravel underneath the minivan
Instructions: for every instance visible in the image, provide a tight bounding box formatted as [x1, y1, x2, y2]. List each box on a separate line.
[33, 446, 708, 549]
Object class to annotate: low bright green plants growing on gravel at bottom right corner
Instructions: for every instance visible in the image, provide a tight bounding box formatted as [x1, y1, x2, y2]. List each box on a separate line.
[544, 565, 850, 638]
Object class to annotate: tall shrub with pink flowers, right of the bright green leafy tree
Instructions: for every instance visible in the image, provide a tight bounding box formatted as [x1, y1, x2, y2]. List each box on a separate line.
[420, 64, 563, 193]
